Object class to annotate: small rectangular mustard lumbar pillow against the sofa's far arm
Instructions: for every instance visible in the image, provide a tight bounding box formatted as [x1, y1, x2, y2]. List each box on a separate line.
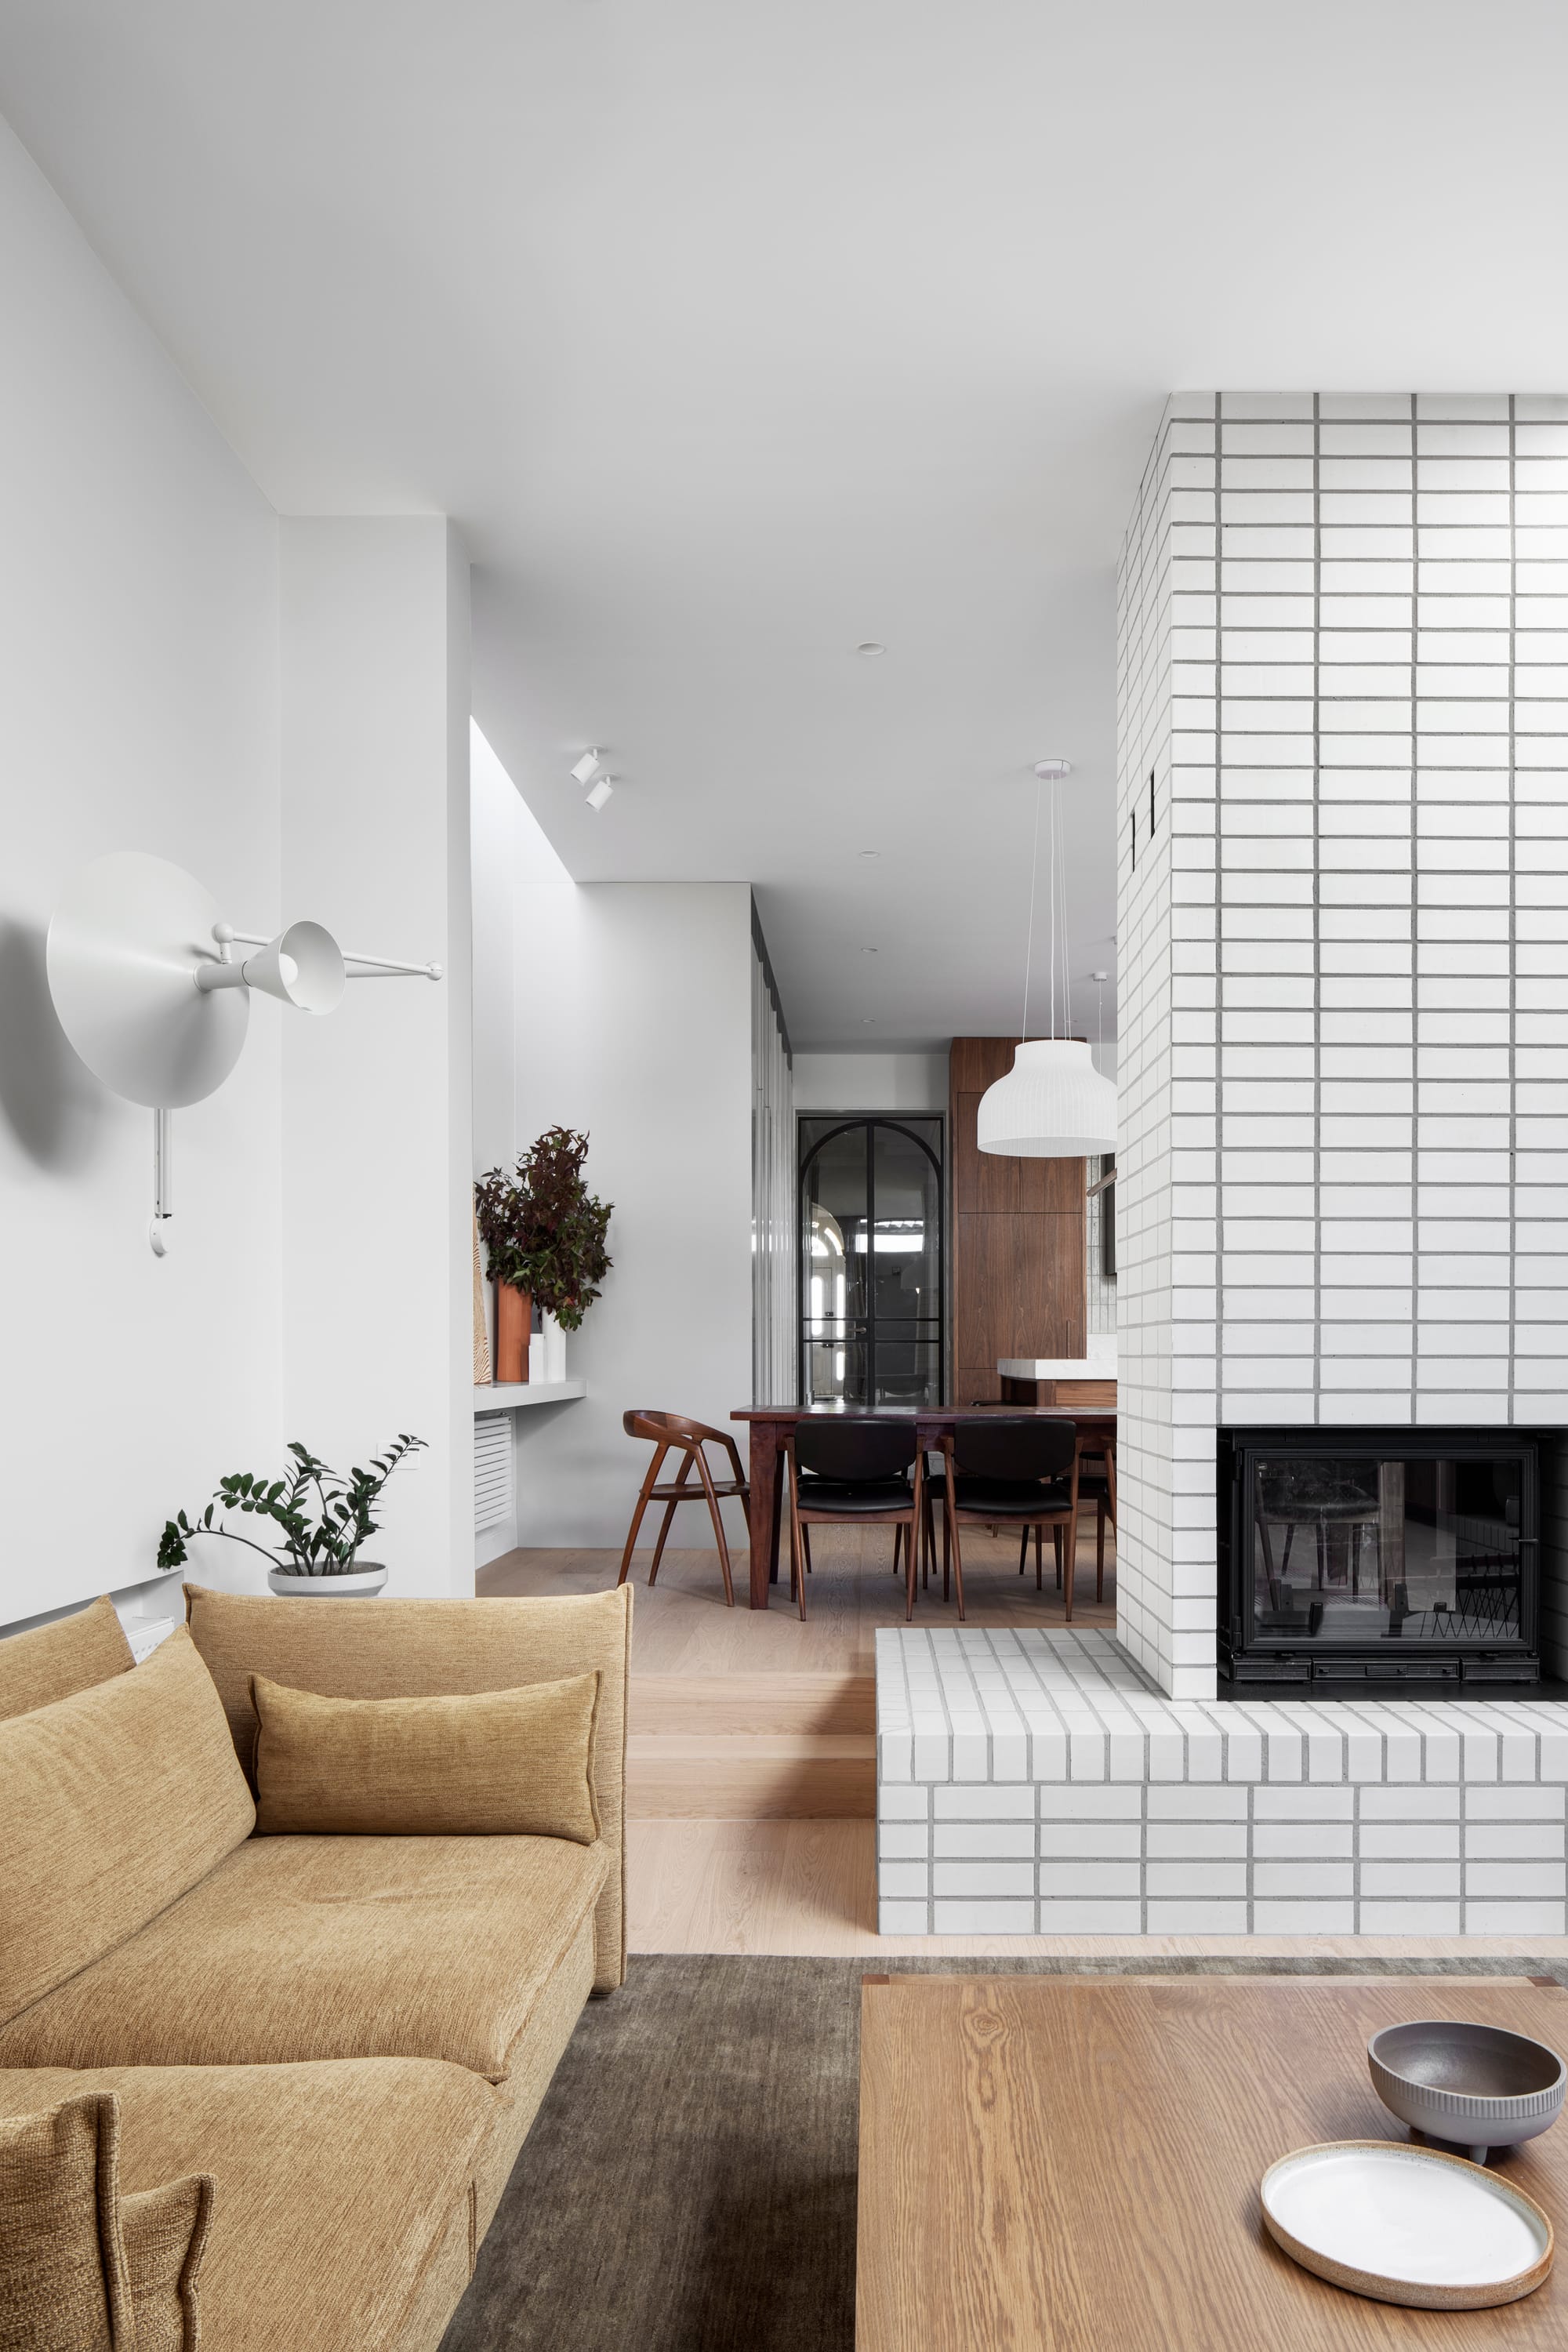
[252, 1675, 600, 1846]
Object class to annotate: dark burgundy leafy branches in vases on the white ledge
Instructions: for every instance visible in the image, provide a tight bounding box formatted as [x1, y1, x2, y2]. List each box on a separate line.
[475, 1127, 614, 1381]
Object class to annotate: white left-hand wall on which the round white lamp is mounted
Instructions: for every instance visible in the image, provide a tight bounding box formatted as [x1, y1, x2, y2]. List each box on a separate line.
[0, 125, 289, 1625]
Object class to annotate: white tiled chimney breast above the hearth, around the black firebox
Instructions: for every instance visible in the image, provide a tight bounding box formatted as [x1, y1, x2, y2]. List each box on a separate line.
[1116, 393, 1568, 1698]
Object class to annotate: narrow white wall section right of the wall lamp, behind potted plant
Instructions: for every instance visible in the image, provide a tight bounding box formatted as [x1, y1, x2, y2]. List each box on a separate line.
[282, 517, 473, 1595]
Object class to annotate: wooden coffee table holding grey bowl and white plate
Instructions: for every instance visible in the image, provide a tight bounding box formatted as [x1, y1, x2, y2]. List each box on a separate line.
[855, 1976, 1568, 2352]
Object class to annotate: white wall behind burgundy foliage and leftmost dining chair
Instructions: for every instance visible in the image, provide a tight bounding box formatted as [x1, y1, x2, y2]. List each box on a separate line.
[475, 755, 753, 1559]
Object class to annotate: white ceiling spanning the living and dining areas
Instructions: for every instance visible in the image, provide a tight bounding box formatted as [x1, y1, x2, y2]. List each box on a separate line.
[0, 0, 1568, 1047]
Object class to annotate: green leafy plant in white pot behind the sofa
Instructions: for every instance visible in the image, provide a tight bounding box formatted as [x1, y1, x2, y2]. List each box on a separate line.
[158, 1432, 426, 1599]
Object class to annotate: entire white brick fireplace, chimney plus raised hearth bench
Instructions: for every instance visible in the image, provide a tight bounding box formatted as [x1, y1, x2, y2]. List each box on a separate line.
[877, 393, 1568, 1936]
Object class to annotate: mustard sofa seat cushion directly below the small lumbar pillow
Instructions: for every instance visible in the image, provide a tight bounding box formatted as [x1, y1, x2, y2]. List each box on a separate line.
[0, 1825, 607, 2082]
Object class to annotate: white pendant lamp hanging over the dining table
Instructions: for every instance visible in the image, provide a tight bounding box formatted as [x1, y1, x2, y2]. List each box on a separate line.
[975, 760, 1116, 1160]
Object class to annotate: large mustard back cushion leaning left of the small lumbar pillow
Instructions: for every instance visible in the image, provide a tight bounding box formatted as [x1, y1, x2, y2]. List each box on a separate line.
[0, 1625, 256, 2018]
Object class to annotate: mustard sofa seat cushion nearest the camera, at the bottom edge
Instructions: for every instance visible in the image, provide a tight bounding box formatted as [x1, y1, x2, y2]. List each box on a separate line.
[0, 2058, 496, 2352]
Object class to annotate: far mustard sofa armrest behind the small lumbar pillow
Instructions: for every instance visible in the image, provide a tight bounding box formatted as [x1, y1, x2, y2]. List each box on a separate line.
[186, 1585, 633, 1992]
